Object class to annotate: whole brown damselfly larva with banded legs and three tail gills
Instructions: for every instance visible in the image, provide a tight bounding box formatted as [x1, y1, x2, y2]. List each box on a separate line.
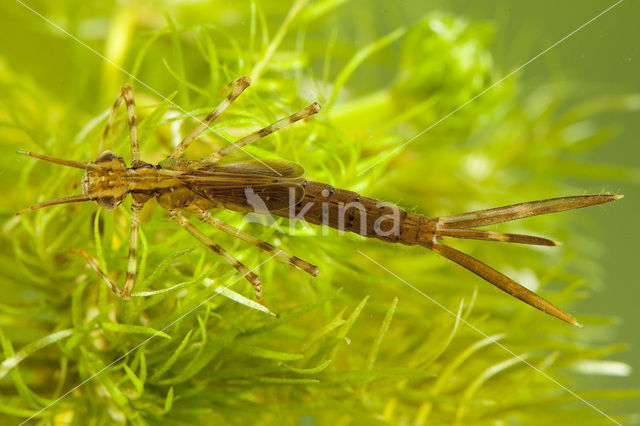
[17, 77, 622, 325]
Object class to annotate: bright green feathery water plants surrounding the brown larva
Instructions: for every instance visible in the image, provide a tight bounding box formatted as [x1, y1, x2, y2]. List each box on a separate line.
[0, 0, 638, 424]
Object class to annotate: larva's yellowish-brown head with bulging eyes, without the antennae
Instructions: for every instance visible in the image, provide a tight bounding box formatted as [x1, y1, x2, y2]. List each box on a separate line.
[82, 151, 129, 210]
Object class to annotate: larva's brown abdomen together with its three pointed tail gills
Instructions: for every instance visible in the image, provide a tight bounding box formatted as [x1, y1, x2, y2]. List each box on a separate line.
[270, 180, 622, 326]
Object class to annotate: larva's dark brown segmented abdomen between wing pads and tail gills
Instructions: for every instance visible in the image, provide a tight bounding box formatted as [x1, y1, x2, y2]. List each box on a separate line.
[272, 181, 433, 245]
